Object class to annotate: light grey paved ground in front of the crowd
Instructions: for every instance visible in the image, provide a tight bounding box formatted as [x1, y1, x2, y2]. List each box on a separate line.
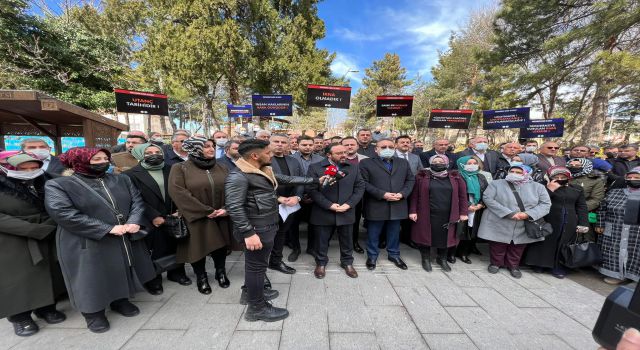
[0, 232, 611, 350]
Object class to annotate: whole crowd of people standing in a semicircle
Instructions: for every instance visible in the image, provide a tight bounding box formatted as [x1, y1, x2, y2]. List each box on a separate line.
[0, 129, 640, 336]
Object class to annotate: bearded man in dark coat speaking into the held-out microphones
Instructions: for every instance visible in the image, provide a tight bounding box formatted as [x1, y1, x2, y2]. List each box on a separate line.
[307, 143, 365, 278]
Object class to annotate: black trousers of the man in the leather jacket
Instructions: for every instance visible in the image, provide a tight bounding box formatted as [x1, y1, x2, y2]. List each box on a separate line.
[244, 225, 278, 306]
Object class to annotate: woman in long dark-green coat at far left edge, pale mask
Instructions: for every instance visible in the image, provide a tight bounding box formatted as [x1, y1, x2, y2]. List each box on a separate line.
[0, 152, 66, 337]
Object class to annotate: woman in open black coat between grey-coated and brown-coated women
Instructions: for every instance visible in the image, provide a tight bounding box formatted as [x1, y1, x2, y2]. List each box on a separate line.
[124, 143, 191, 295]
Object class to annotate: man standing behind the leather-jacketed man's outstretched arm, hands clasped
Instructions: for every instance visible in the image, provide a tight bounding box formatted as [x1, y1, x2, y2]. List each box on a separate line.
[269, 134, 304, 274]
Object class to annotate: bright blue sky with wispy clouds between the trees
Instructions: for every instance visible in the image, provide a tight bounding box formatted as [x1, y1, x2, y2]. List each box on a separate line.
[318, 0, 495, 93]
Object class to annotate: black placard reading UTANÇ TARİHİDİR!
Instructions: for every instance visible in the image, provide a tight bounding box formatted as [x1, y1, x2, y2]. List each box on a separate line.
[113, 89, 169, 116]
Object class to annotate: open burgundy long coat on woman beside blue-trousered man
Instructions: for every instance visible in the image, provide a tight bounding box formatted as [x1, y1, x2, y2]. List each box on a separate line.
[409, 170, 469, 247]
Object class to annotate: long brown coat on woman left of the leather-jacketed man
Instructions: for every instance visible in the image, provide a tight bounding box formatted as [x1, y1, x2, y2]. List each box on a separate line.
[169, 160, 231, 263]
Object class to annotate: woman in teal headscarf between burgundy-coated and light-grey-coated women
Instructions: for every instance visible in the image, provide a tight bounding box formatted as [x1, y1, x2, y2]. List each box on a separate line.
[456, 156, 492, 264]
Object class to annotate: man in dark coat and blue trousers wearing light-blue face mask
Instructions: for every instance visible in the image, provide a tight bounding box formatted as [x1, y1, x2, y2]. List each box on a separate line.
[359, 139, 415, 270]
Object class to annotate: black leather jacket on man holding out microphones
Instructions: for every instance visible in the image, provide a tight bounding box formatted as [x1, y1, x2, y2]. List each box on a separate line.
[224, 169, 318, 241]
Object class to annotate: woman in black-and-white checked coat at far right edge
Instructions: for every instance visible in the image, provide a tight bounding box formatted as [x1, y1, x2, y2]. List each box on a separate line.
[595, 167, 640, 284]
